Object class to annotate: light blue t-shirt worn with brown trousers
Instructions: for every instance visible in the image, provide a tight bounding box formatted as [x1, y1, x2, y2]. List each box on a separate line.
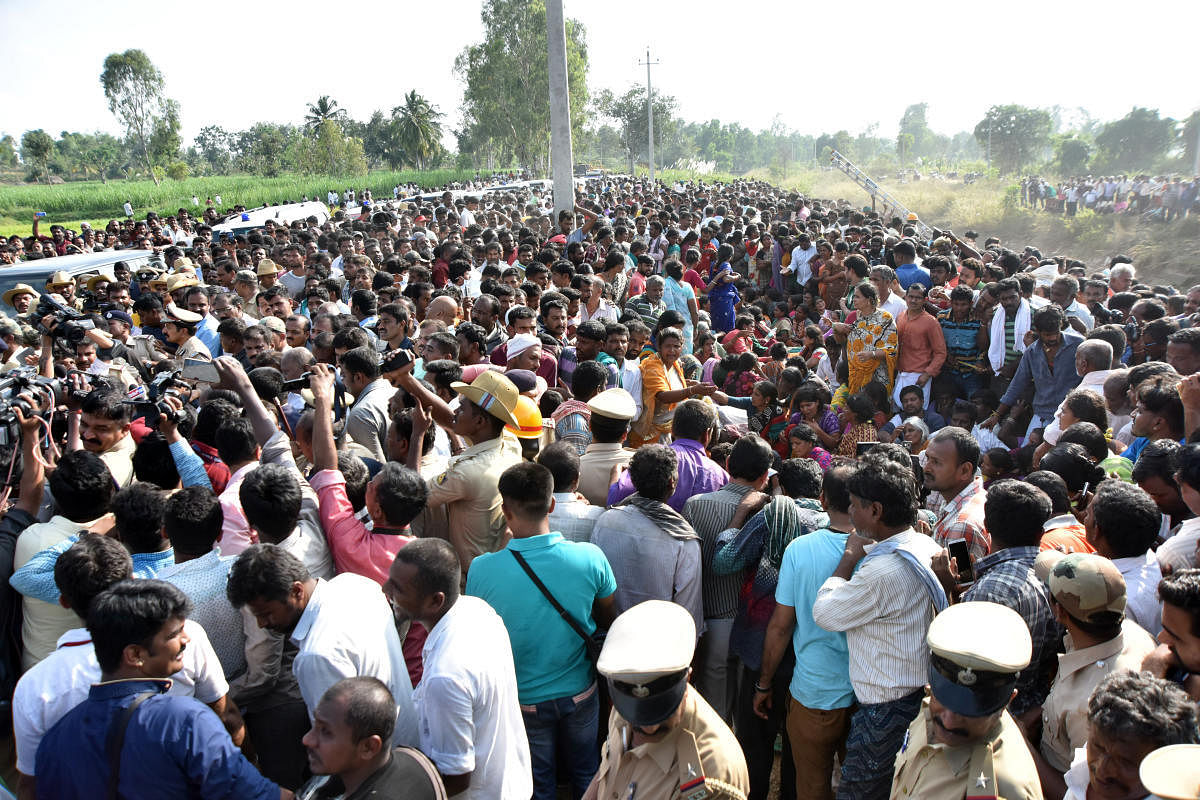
[775, 528, 854, 711]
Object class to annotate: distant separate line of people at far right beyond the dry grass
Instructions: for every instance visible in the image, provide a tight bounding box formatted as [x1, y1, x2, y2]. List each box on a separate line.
[1019, 174, 1200, 222]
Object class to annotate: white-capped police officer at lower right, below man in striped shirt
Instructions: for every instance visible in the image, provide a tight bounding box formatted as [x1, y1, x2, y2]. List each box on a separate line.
[892, 602, 1042, 800]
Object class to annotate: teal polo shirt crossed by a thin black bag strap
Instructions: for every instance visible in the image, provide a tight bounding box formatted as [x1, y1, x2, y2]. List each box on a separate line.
[467, 533, 617, 705]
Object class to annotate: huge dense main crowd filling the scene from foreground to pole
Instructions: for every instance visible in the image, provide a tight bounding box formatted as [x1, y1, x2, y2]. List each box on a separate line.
[0, 178, 1200, 800]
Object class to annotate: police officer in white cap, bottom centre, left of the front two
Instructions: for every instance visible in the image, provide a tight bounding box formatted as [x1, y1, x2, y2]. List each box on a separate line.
[583, 600, 750, 800]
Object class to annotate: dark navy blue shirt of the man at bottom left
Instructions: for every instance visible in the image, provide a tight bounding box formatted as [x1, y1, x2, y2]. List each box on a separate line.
[35, 680, 280, 800]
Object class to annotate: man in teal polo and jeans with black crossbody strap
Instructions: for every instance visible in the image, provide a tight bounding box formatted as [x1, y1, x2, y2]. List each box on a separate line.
[467, 462, 617, 800]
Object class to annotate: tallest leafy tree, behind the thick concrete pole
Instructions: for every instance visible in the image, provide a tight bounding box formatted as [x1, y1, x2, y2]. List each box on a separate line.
[455, 0, 588, 168]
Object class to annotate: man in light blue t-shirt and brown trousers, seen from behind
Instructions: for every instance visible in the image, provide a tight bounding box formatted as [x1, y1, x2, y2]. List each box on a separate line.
[754, 465, 854, 800]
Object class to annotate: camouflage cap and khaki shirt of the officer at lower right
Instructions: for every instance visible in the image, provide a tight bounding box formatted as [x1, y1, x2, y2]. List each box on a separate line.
[1039, 553, 1157, 772]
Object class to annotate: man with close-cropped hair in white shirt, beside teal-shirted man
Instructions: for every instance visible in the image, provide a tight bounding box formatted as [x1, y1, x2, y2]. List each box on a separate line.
[383, 539, 533, 800]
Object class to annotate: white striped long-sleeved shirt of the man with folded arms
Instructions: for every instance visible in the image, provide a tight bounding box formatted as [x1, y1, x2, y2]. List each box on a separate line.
[812, 528, 942, 704]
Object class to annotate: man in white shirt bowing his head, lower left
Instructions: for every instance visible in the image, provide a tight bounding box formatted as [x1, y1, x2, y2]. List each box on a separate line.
[228, 545, 419, 746]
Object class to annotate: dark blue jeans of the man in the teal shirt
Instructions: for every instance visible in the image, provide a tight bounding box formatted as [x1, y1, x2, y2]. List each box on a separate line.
[521, 684, 600, 800]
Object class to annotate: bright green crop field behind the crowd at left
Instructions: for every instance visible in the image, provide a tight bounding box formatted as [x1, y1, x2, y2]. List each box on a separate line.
[0, 169, 474, 236]
